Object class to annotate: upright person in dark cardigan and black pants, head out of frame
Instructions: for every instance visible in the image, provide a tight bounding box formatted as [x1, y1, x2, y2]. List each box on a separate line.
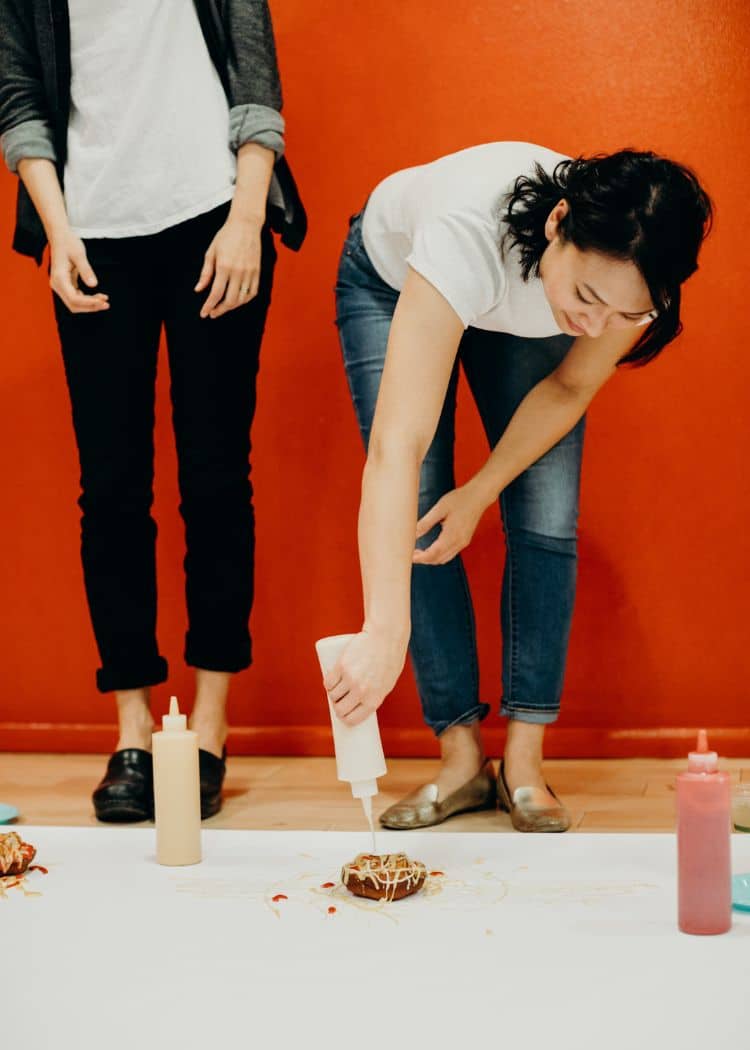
[0, 0, 305, 821]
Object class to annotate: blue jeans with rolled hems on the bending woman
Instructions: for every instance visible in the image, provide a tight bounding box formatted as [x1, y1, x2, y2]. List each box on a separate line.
[336, 215, 585, 736]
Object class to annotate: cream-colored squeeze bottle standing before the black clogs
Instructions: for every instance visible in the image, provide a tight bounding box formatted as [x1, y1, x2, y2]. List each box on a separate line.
[151, 696, 201, 865]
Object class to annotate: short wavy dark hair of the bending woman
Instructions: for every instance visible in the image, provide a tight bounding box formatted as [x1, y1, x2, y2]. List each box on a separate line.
[502, 149, 713, 365]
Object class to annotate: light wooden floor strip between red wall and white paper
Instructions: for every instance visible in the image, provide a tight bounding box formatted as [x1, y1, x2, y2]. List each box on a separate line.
[0, 753, 750, 832]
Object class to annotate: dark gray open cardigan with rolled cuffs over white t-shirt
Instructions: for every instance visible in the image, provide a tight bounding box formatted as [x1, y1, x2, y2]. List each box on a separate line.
[0, 0, 307, 261]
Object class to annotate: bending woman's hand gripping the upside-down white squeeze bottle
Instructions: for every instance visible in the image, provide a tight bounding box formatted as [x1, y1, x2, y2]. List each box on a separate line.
[322, 628, 407, 726]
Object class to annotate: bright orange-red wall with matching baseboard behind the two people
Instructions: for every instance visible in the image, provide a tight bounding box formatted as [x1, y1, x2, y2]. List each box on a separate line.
[0, 0, 750, 755]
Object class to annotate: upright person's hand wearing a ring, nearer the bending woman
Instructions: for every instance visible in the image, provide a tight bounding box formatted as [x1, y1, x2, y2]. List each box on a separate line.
[195, 214, 262, 317]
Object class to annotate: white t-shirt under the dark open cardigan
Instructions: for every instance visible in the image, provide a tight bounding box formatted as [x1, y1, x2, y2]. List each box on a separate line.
[65, 0, 235, 237]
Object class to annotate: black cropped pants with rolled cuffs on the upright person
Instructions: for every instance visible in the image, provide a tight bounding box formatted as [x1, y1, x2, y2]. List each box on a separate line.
[55, 205, 276, 692]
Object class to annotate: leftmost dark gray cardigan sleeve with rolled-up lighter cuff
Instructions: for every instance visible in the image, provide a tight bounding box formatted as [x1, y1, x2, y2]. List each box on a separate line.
[0, 0, 56, 172]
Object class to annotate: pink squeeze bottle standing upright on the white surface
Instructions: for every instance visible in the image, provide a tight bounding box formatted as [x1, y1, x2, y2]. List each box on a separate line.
[676, 729, 732, 933]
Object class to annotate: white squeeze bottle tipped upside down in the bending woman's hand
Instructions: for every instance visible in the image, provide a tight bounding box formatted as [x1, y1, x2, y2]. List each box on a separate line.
[315, 634, 387, 848]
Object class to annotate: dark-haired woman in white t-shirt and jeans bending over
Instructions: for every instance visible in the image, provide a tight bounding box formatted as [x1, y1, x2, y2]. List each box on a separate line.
[326, 142, 711, 832]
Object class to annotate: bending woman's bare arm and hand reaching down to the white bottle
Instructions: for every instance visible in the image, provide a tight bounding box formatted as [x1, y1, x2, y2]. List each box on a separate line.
[326, 270, 463, 725]
